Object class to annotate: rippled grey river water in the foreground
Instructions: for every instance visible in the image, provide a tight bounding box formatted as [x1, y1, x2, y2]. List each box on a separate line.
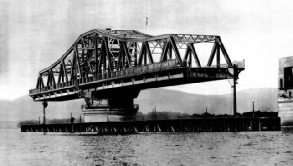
[0, 129, 293, 166]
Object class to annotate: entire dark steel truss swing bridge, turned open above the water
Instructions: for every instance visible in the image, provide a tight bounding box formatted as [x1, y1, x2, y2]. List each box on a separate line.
[29, 29, 245, 120]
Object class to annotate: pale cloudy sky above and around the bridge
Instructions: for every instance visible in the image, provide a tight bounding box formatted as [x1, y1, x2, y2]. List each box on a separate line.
[0, 0, 293, 100]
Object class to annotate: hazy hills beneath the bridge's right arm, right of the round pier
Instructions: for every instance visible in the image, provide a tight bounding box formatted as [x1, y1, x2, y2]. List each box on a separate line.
[135, 88, 277, 114]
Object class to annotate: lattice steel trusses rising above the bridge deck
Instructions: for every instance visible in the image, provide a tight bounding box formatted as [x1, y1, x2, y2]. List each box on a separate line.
[30, 29, 232, 93]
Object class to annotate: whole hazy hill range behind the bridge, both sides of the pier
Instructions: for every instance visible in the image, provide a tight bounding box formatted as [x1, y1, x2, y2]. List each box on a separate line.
[0, 88, 277, 128]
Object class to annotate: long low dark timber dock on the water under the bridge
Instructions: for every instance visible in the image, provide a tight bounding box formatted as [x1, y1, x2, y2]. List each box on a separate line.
[21, 117, 281, 135]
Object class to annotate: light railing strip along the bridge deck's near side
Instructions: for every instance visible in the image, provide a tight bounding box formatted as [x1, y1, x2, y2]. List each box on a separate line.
[29, 59, 179, 95]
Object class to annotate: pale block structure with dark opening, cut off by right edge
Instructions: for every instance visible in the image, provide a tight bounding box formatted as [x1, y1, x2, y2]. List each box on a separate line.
[278, 56, 293, 123]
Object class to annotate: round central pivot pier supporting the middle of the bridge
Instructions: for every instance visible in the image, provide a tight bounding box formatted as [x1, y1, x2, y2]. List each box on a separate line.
[81, 89, 139, 122]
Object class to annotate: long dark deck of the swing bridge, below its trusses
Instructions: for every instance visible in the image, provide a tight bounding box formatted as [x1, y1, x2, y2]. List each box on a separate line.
[29, 60, 244, 101]
